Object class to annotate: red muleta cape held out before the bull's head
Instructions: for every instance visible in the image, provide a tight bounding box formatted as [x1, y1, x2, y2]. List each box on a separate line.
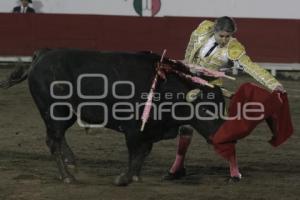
[212, 83, 293, 160]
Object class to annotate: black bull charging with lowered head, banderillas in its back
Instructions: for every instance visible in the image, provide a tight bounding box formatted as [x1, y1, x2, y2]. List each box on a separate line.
[1, 49, 224, 185]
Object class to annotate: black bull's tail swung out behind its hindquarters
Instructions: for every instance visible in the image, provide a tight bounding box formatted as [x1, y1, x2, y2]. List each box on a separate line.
[0, 49, 50, 89]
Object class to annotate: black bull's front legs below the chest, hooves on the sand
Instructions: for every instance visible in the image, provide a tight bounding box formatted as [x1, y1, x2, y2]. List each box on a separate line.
[115, 140, 152, 186]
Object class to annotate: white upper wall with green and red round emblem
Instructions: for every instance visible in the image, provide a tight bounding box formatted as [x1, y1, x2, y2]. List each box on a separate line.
[0, 0, 300, 19]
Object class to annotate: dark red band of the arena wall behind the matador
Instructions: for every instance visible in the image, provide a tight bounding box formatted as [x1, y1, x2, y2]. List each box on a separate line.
[0, 13, 300, 63]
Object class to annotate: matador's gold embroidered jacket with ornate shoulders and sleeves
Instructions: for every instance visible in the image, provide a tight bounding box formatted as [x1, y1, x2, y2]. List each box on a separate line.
[185, 20, 280, 90]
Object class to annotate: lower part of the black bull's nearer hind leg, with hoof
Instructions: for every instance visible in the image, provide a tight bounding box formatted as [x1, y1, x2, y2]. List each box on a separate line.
[46, 129, 75, 183]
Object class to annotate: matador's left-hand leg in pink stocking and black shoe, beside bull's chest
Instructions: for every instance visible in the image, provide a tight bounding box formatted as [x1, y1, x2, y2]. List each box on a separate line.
[163, 125, 193, 180]
